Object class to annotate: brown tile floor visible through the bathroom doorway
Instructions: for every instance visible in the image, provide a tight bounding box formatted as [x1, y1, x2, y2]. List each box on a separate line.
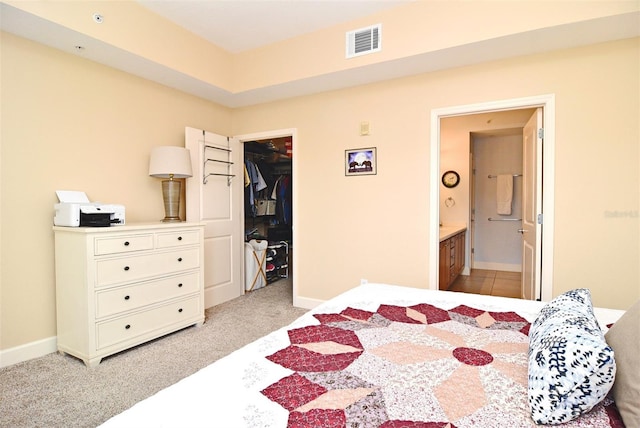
[449, 269, 520, 298]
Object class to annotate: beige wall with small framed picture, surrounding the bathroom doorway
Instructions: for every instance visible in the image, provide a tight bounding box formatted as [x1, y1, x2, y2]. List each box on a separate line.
[233, 39, 640, 308]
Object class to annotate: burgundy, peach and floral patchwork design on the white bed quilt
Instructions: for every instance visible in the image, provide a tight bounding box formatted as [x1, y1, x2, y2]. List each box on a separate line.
[261, 304, 623, 428]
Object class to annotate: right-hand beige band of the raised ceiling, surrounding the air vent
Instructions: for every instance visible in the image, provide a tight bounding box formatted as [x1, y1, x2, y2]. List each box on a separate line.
[234, 0, 639, 91]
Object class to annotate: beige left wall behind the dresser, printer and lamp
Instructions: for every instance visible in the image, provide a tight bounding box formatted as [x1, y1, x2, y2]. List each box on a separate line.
[0, 33, 231, 349]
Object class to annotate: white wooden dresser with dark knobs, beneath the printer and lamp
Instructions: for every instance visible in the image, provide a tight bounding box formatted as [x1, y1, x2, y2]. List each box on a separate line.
[53, 223, 204, 367]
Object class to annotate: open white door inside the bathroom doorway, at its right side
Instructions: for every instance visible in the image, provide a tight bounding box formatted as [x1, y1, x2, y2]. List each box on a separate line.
[519, 108, 542, 300]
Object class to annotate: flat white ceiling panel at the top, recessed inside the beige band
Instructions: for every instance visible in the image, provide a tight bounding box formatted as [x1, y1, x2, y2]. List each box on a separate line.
[136, 0, 415, 53]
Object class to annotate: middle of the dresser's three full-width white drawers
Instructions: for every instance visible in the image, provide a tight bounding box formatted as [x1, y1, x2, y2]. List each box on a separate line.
[96, 272, 200, 318]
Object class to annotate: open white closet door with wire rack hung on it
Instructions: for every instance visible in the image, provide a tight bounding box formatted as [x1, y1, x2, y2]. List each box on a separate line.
[185, 127, 244, 308]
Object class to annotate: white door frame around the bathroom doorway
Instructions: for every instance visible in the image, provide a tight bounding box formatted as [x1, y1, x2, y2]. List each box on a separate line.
[428, 94, 555, 301]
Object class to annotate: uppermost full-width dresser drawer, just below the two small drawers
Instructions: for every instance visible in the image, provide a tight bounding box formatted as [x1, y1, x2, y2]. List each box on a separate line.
[95, 248, 200, 287]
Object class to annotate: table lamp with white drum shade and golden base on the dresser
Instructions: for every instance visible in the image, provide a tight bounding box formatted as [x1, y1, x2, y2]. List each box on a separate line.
[149, 146, 192, 222]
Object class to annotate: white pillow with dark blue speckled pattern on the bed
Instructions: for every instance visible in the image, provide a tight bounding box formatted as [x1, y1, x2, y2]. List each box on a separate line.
[528, 288, 616, 424]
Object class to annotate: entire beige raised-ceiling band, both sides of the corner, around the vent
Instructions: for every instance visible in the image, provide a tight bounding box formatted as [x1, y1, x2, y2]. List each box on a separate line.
[5, 0, 640, 93]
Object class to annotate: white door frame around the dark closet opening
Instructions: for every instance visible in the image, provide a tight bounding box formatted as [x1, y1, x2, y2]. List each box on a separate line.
[234, 128, 298, 306]
